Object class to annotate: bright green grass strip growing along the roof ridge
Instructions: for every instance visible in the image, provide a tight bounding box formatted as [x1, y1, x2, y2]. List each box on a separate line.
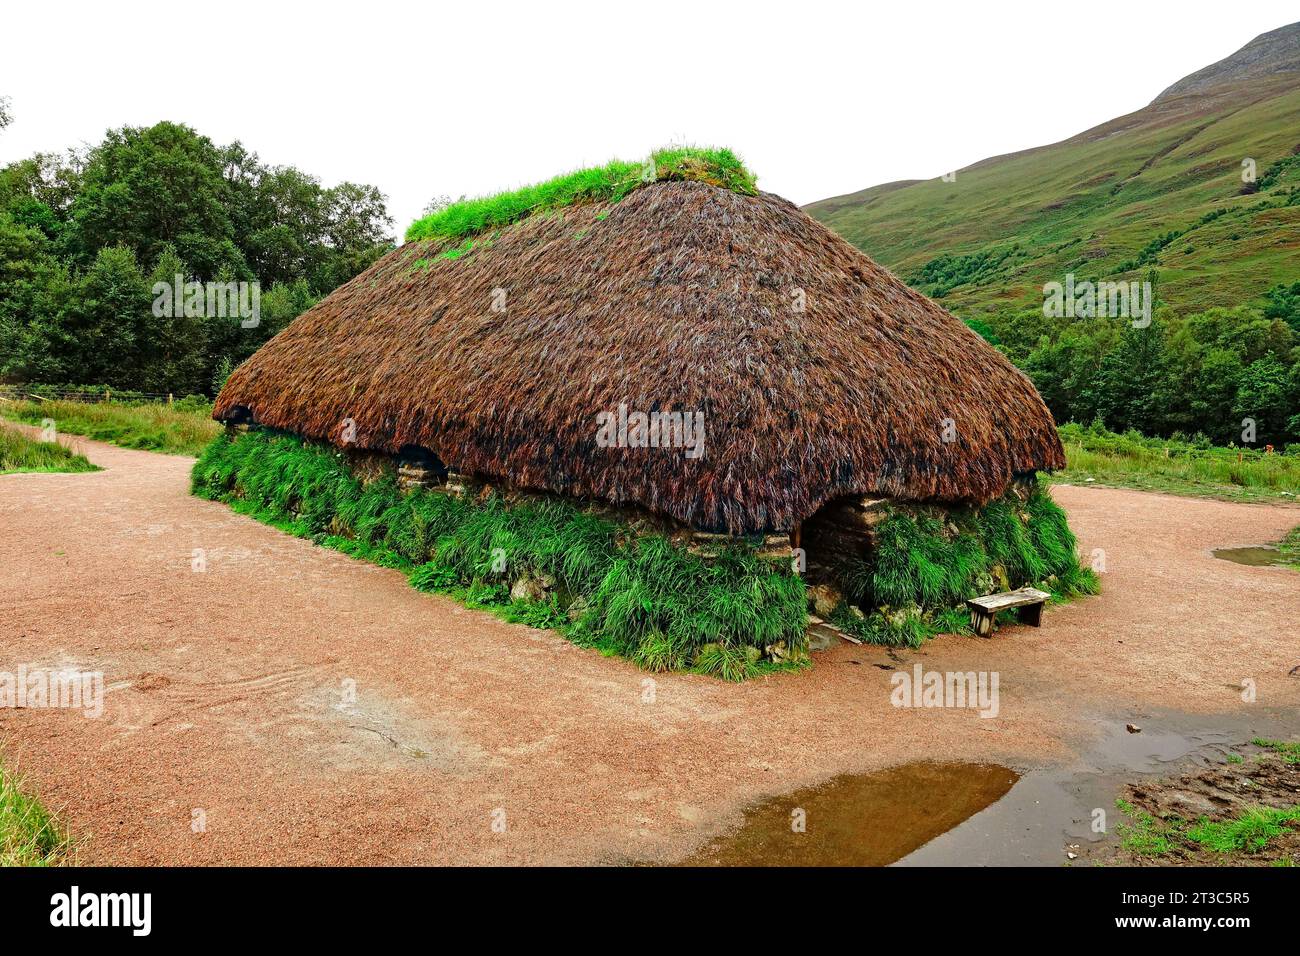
[406, 146, 757, 242]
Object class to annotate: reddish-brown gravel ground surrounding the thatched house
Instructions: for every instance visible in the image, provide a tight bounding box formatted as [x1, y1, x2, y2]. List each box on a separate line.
[0, 441, 1300, 864]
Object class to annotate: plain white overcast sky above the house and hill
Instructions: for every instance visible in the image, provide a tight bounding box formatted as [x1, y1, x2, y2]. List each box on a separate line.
[0, 0, 1300, 235]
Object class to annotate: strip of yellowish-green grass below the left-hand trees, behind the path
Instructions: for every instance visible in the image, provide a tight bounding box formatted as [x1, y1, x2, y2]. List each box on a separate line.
[0, 399, 221, 455]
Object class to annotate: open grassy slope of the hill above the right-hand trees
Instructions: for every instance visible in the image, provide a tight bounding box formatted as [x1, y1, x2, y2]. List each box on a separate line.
[807, 25, 1300, 319]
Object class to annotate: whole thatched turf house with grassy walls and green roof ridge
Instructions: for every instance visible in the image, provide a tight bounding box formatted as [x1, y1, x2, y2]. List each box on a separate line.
[194, 148, 1095, 679]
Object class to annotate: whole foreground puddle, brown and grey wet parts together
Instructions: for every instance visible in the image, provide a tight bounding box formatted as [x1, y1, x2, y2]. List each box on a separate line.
[684, 709, 1300, 866]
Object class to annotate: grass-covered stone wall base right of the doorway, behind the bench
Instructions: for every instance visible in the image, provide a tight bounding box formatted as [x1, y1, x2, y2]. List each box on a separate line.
[832, 488, 1100, 646]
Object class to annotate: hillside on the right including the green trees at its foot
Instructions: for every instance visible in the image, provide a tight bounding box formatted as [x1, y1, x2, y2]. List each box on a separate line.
[806, 23, 1300, 455]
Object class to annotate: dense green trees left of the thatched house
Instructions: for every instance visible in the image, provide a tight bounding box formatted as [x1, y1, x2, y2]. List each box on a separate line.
[0, 117, 393, 395]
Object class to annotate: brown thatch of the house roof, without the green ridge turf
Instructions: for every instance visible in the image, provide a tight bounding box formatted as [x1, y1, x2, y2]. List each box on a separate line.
[215, 182, 1065, 533]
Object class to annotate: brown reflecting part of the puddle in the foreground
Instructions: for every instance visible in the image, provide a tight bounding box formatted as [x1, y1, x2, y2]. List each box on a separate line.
[683, 762, 1019, 866]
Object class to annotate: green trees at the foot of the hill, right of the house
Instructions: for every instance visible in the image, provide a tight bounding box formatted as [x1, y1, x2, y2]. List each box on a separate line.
[970, 284, 1300, 449]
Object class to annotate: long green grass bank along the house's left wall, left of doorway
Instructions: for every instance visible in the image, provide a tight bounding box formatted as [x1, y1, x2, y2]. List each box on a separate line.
[192, 431, 807, 680]
